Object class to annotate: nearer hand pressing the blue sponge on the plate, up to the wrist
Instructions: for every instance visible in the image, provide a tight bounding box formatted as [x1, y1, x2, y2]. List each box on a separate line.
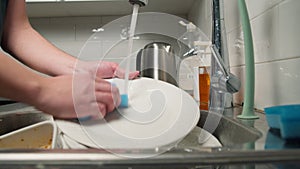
[35, 72, 120, 118]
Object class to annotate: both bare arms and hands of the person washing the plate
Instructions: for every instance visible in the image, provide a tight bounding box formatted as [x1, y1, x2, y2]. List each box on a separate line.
[0, 0, 138, 118]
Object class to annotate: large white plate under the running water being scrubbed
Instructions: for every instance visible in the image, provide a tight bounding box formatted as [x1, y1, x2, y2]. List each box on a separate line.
[58, 78, 200, 152]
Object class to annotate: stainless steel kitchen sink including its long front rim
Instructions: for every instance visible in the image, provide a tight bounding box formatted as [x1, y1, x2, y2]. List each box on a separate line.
[0, 103, 300, 168]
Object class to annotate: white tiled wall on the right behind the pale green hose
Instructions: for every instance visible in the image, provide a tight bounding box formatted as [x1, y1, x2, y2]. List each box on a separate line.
[189, 0, 300, 109]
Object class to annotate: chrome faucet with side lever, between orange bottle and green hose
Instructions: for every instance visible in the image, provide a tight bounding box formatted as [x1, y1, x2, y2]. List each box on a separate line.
[210, 0, 241, 109]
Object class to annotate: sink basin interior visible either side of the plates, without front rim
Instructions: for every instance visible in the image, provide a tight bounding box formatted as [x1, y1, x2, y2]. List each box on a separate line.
[0, 103, 262, 149]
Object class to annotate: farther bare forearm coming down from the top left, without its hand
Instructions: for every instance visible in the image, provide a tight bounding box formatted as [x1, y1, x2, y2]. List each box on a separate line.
[2, 0, 76, 76]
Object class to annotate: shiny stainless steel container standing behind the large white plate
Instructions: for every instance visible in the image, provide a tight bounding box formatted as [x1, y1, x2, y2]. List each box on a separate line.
[136, 42, 178, 86]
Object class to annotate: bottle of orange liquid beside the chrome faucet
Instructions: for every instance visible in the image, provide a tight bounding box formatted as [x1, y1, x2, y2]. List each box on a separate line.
[199, 67, 210, 110]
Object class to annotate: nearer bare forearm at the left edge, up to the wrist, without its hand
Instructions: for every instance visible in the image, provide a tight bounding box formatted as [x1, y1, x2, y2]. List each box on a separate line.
[0, 52, 45, 104]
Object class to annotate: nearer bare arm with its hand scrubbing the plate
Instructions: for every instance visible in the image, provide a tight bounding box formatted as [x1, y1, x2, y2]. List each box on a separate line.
[0, 52, 120, 118]
